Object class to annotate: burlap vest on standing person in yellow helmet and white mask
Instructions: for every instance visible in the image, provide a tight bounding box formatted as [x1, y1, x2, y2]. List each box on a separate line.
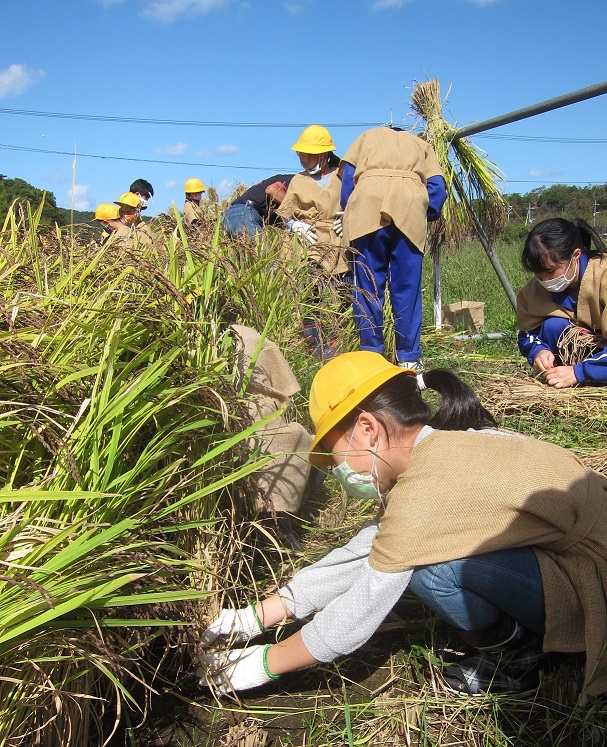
[276, 169, 349, 275]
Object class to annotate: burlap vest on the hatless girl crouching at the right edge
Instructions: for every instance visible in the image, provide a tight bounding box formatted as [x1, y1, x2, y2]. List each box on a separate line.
[516, 257, 607, 341]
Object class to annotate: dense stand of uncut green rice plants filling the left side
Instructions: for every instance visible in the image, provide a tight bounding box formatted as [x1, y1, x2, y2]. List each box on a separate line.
[0, 196, 324, 745]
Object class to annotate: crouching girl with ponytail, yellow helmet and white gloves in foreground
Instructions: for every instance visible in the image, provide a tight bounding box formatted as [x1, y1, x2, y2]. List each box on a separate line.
[200, 351, 607, 695]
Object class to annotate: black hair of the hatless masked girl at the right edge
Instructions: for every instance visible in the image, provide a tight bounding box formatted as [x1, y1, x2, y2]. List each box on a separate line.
[521, 218, 607, 273]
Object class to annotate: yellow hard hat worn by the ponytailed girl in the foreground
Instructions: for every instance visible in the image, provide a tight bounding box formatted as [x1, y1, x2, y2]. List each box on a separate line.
[309, 350, 415, 467]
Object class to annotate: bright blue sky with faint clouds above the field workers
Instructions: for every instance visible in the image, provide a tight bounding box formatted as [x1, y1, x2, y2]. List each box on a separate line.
[0, 0, 607, 215]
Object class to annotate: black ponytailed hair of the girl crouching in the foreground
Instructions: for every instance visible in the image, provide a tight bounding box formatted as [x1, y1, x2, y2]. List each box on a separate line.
[344, 368, 497, 431]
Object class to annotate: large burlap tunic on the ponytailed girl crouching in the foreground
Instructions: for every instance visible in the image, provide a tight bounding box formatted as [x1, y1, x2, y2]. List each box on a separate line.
[369, 431, 607, 695]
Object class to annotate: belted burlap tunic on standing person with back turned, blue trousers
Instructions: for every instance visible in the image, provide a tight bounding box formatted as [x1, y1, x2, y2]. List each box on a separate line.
[342, 127, 442, 252]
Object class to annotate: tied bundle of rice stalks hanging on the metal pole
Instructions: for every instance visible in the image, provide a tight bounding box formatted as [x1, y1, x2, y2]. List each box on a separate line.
[411, 78, 506, 253]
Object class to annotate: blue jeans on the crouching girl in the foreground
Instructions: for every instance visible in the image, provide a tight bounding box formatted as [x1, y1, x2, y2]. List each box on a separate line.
[409, 547, 546, 635]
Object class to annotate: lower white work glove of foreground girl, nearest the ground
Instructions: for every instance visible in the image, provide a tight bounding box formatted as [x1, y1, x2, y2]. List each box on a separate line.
[196, 643, 280, 695]
